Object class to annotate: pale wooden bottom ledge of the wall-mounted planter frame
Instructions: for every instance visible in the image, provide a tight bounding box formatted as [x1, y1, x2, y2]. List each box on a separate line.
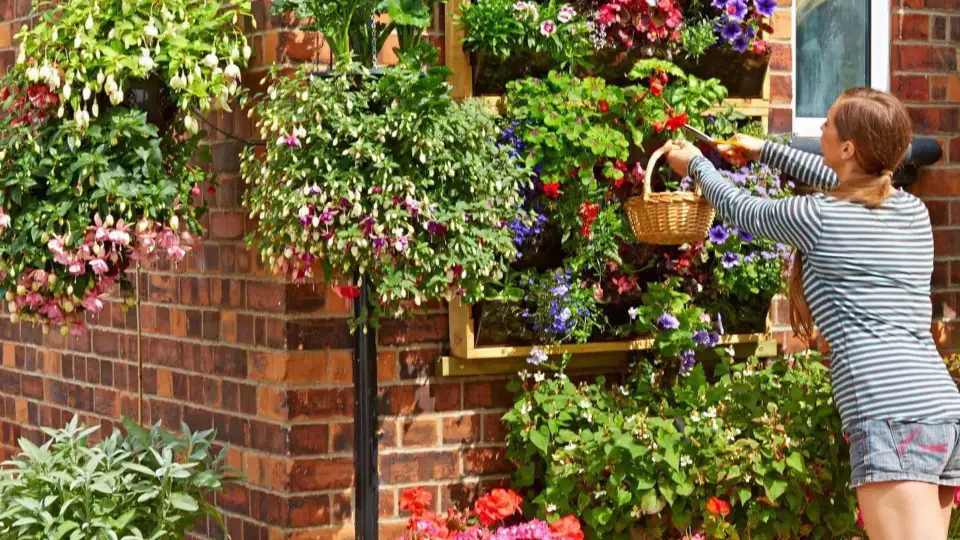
[437, 302, 777, 377]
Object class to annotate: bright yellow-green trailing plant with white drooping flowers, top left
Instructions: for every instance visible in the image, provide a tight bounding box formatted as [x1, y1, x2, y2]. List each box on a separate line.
[14, 0, 256, 133]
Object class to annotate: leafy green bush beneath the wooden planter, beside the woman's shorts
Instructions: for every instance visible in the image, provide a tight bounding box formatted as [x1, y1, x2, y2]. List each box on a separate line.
[504, 353, 859, 540]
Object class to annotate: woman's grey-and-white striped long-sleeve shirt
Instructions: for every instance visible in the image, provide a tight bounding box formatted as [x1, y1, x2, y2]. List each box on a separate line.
[689, 143, 960, 427]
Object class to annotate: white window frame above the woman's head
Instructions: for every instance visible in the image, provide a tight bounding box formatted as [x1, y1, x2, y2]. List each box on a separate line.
[790, 0, 890, 137]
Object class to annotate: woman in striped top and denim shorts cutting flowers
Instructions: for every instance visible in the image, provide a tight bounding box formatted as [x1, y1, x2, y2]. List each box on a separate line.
[668, 88, 960, 540]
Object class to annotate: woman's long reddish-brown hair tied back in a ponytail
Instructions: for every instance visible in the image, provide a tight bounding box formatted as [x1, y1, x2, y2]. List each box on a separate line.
[789, 87, 912, 341]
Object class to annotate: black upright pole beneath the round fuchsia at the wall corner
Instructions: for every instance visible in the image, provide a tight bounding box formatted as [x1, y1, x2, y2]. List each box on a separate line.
[353, 279, 380, 540]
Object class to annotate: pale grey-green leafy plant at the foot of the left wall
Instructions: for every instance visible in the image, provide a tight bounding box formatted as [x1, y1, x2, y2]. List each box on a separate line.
[0, 417, 237, 540]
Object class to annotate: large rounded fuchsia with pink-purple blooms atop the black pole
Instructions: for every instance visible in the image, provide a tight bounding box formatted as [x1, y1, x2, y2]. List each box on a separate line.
[242, 59, 528, 319]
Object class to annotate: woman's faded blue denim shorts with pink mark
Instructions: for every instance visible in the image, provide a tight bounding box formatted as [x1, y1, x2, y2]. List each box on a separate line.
[845, 420, 960, 488]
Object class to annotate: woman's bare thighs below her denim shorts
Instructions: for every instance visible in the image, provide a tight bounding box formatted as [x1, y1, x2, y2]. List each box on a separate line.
[857, 482, 952, 540]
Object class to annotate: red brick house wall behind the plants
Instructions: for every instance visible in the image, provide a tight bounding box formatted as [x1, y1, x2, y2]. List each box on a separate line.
[0, 0, 960, 540]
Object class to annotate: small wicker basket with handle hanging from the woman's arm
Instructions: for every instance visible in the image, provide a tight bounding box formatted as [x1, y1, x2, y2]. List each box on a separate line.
[625, 143, 716, 246]
